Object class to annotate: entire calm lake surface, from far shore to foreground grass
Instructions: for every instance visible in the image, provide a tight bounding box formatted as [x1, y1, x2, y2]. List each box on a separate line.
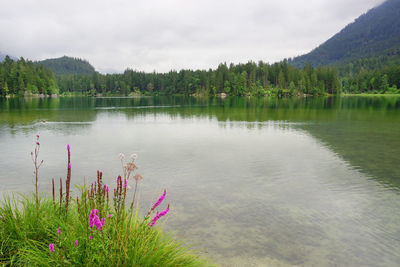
[0, 97, 400, 266]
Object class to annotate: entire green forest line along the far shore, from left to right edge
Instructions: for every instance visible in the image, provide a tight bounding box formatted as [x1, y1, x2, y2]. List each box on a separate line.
[0, 57, 400, 96]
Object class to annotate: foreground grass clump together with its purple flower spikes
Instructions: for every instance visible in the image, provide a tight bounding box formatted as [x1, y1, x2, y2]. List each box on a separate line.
[0, 139, 210, 266]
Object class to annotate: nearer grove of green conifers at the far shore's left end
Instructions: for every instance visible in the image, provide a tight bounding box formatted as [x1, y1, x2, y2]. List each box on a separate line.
[0, 56, 59, 96]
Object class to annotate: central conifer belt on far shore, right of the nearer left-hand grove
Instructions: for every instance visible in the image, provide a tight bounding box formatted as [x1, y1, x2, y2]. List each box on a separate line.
[57, 60, 341, 96]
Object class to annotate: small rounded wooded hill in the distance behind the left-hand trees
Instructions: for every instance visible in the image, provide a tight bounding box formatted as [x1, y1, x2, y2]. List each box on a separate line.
[36, 56, 95, 75]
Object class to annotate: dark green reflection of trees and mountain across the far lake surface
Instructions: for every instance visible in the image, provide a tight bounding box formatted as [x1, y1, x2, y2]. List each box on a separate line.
[0, 96, 400, 186]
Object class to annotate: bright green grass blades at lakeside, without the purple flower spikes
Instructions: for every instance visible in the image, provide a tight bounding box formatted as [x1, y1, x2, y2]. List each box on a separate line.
[0, 197, 211, 266]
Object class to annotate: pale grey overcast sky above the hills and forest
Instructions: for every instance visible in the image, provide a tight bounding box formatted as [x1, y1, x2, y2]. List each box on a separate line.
[0, 0, 383, 73]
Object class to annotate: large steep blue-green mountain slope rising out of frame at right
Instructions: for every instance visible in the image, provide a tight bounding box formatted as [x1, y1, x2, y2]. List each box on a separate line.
[289, 0, 400, 67]
